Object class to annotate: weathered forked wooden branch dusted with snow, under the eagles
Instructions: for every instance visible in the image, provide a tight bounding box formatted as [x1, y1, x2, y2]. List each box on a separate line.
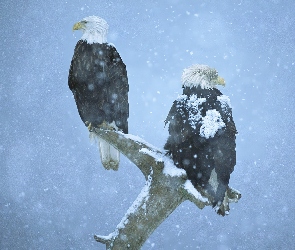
[91, 128, 241, 250]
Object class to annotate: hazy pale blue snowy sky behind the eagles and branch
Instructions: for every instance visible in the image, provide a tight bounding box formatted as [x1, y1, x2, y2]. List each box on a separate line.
[0, 0, 295, 250]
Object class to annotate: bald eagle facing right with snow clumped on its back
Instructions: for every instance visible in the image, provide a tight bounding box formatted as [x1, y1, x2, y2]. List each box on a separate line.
[164, 65, 237, 215]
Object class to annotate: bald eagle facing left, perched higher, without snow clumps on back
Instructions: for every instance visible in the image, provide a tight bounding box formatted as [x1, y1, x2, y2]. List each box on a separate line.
[68, 16, 129, 170]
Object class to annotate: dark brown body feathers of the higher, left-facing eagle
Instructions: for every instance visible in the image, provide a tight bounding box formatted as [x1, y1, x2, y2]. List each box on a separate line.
[68, 40, 129, 133]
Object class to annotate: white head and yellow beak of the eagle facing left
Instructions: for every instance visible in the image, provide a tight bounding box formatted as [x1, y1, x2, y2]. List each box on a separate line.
[73, 16, 109, 44]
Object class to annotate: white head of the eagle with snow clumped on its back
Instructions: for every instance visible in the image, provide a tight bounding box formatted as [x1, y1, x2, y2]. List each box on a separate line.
[181, 64, 225, 89]
